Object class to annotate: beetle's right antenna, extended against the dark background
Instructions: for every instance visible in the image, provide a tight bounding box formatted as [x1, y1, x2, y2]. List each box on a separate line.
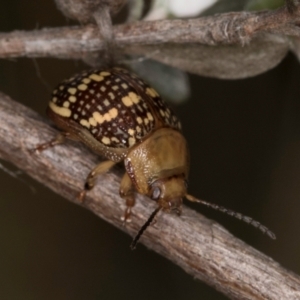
[185, 195, 276, 240]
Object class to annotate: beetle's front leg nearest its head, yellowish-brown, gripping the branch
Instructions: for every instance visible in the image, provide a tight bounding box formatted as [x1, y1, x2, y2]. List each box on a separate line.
[119, 173, 135, 225]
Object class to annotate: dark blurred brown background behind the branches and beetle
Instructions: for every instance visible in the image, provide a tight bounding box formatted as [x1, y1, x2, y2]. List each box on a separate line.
[0, 0, 300, 300]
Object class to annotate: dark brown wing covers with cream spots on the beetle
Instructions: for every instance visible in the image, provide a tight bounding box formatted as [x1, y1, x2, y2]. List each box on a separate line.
[49, 68, 181, 148]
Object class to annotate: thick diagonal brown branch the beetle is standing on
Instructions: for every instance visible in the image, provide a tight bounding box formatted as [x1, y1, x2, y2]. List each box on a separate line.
[0, 94, 300, 300]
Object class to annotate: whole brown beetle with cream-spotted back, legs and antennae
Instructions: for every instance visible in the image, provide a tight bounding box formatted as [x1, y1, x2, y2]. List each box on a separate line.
[36, 67, 275, 248]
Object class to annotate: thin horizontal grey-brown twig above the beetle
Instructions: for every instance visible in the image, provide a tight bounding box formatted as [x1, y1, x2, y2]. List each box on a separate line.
[0, 5, 300, 59]
